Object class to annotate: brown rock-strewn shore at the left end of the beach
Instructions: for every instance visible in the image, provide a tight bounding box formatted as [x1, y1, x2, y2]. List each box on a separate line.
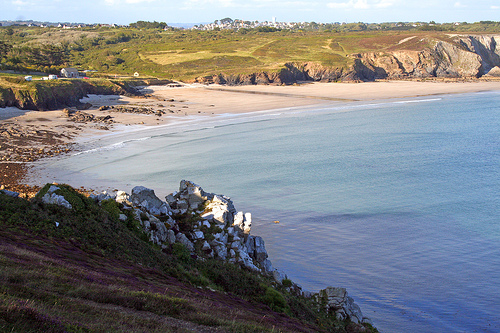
[0, 95, 184, 196]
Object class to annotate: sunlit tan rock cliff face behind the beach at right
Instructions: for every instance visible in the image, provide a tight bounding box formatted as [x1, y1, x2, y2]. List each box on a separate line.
[195, 35, 500, 85]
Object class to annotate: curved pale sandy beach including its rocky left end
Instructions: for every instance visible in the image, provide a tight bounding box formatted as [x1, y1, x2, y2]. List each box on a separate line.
[0, 81, 500, 193]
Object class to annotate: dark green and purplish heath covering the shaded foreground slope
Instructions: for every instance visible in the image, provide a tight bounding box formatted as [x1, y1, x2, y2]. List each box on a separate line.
[0, 185, 376, 332]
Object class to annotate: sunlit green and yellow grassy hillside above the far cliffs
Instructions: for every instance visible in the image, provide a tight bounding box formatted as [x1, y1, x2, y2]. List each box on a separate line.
[0, 25, 482, 81]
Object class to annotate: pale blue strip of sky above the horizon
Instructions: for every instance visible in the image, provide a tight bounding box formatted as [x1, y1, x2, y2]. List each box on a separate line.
[0, 0, 500, 24]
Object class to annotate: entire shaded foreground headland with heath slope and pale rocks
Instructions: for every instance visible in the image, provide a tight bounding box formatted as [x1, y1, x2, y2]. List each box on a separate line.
[0, 181, 378, 333]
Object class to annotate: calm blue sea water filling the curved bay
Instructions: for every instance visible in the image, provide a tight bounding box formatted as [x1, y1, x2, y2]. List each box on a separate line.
[32, 92, 500, 332]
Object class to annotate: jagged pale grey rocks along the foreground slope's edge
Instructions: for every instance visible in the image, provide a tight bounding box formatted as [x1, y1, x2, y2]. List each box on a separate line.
[30, 180, 371, 324]
